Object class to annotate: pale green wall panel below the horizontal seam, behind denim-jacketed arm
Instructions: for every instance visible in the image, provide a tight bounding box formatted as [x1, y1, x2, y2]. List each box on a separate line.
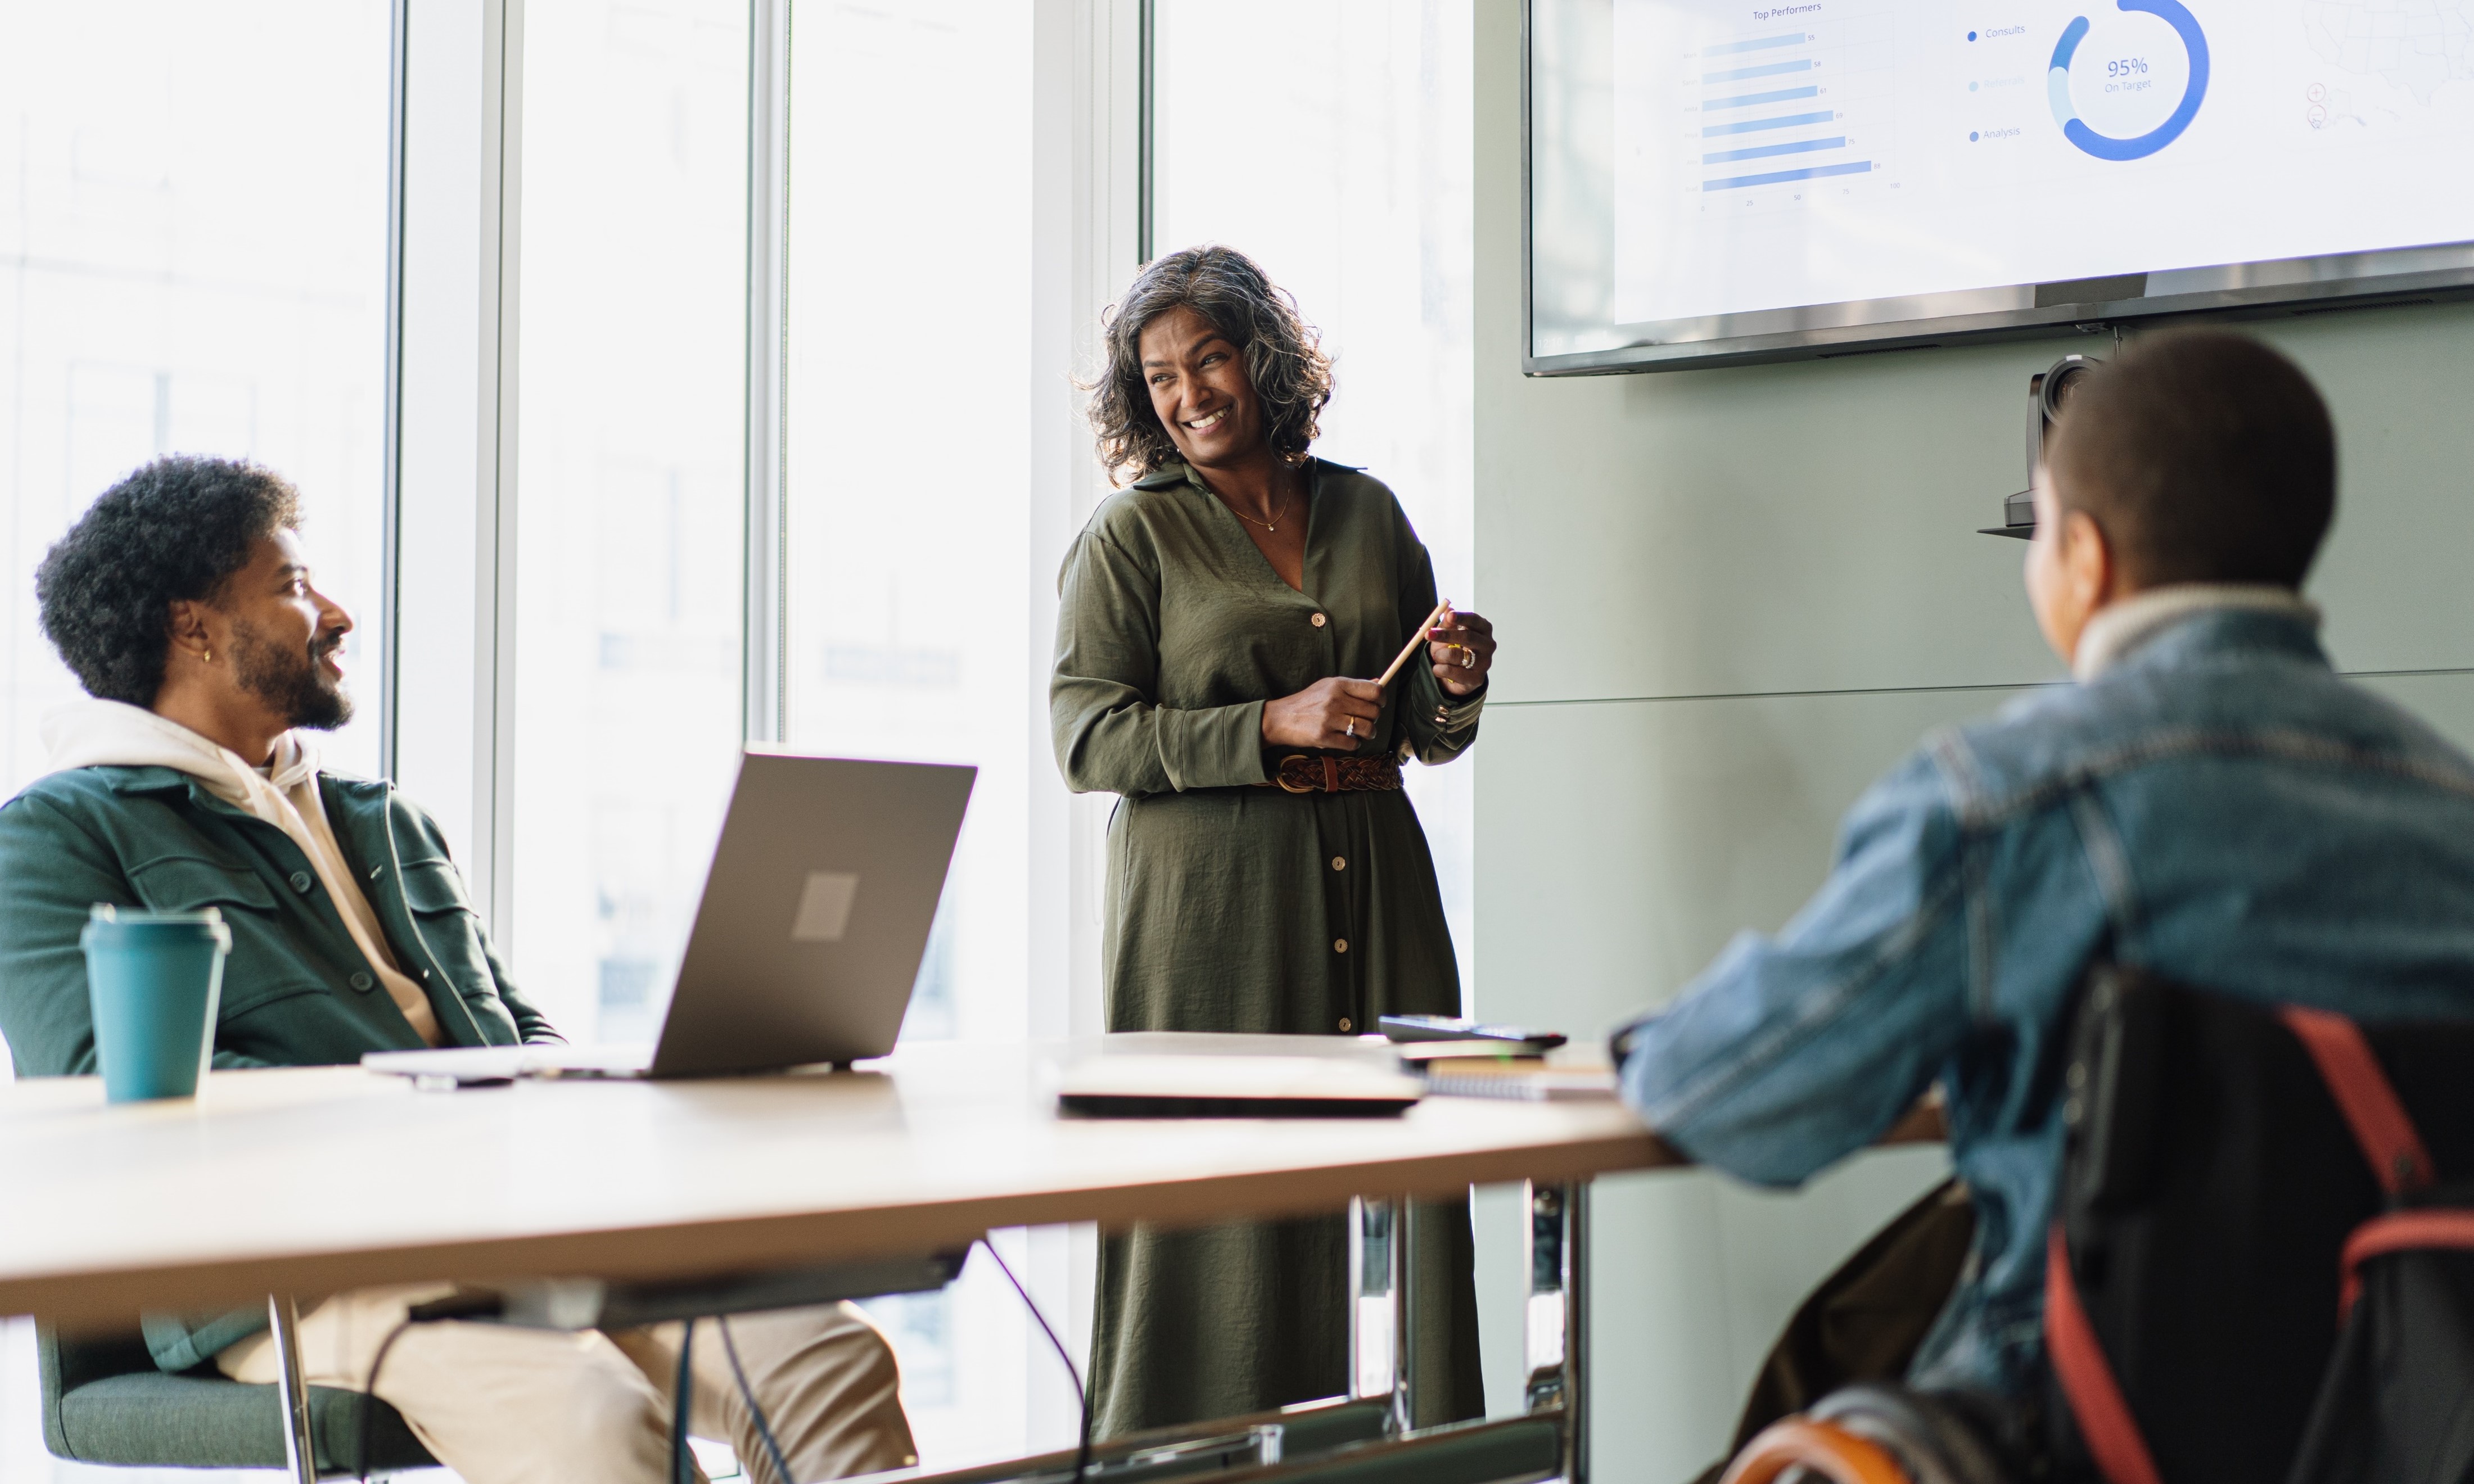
[1477, 690, 1989, 1482]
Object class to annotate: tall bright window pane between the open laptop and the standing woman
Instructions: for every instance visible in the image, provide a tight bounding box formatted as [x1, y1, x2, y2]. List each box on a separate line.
[784, 0, 1074, 1464]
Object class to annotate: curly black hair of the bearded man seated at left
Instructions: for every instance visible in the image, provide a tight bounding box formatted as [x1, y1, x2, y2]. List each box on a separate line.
[35, 453, 302, 707]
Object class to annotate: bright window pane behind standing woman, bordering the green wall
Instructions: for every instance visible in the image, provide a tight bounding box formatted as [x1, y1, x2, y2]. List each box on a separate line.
[1150, 0, 1474, 984]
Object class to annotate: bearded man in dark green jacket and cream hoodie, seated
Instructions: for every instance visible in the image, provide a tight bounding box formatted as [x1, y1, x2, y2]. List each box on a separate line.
[0, 458, 913, 1484]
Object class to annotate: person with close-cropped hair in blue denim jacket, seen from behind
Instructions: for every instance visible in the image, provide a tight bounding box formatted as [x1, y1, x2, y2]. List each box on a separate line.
[1618, 332, 2474, 1395]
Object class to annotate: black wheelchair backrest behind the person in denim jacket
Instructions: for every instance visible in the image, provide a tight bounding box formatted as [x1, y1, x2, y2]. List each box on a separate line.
[2048, 967, 2474, 1482]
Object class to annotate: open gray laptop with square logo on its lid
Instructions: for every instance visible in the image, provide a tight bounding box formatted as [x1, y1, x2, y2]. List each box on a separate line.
[361, 747, 979, 1083]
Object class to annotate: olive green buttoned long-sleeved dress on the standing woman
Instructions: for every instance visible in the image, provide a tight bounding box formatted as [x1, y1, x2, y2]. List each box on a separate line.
[1049, 460, 1484, 1437]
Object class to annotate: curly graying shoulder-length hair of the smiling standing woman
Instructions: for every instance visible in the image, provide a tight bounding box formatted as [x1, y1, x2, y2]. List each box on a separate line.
[1086, 245, 1331, 480]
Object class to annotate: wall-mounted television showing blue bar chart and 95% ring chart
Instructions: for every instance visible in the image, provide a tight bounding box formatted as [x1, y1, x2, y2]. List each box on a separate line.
[1522, 0, 2474, 373]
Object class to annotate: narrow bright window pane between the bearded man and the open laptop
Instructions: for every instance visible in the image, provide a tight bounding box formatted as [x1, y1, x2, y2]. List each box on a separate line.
[502, 0, 747, 1041]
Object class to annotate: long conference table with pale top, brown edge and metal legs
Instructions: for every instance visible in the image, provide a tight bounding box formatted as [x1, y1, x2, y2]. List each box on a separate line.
[0, 1034, 1937, 1479]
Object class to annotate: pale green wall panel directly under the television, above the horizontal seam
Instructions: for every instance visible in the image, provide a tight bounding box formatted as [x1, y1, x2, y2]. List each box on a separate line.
[1477, 233, 2474, 700]
